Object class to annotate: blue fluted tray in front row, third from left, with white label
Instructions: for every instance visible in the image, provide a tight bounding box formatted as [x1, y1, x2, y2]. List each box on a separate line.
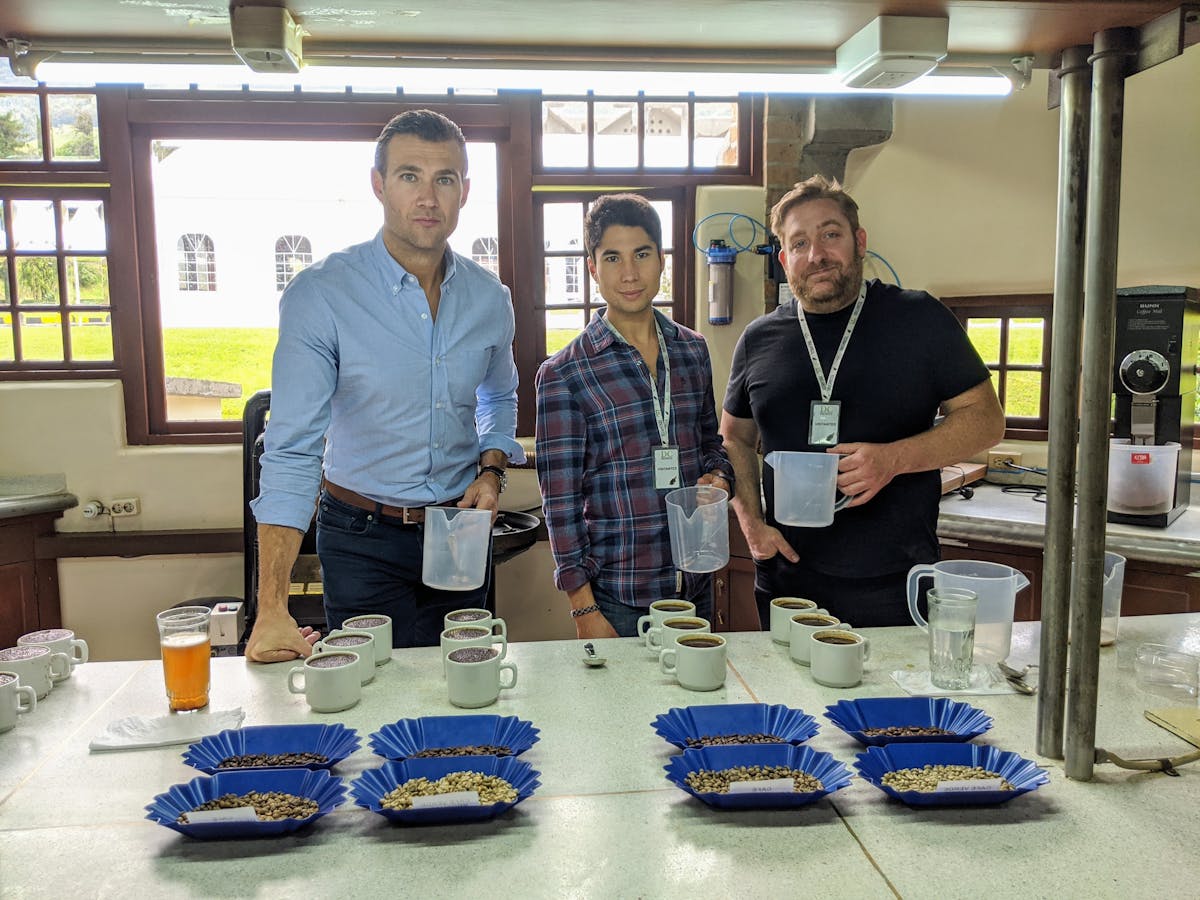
[664, 744, 851, 809]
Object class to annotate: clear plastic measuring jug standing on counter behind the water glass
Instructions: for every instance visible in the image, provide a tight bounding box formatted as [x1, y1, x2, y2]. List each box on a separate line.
[908, 559, 1030, 662]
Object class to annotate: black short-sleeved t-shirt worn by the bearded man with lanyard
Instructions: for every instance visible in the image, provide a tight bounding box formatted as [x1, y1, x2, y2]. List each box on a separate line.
[725, 280, 990, 577]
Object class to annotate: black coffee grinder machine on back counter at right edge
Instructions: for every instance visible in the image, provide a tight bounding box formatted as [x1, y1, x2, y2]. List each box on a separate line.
[1108, 284, 1200, 528]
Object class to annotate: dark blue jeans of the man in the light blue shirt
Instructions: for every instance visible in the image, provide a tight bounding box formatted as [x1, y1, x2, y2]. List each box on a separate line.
[317, 493, 492, 647]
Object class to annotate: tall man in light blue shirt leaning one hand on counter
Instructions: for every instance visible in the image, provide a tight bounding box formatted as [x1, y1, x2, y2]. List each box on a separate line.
[246, 109, 524, 662]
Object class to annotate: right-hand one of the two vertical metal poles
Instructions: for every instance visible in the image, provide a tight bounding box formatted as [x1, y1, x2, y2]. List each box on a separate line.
[1066, 28, 1138, 781]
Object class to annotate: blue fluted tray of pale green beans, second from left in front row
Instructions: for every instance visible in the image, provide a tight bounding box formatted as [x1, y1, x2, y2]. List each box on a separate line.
[350, 756, 541, 824]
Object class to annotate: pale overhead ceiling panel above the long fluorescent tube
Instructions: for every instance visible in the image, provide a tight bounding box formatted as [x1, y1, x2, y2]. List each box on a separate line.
[0, 0, 1181, 66]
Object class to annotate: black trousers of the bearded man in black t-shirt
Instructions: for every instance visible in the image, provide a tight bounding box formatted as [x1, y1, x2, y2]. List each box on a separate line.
[754, 554, 912, 629]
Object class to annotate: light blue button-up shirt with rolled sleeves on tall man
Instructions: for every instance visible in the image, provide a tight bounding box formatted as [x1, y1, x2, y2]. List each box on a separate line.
[251, 232, 524, 532]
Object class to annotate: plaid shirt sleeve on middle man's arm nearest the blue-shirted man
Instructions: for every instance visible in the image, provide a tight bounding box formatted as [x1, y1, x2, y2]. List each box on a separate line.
[534, 362, 600, 590]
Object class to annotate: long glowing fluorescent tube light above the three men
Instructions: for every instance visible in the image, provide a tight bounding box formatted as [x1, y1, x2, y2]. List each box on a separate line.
[30, 60, 1012, 96]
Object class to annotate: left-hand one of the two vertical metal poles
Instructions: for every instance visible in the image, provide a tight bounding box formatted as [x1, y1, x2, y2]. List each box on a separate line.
[1037, 46, 1092, 760]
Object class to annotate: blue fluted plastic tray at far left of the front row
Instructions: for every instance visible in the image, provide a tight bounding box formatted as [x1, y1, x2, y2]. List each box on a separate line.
[146, 769, 346, 840]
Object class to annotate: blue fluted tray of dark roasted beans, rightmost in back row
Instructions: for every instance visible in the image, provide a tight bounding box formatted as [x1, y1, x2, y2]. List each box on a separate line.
[826, 697, 991, 746]
